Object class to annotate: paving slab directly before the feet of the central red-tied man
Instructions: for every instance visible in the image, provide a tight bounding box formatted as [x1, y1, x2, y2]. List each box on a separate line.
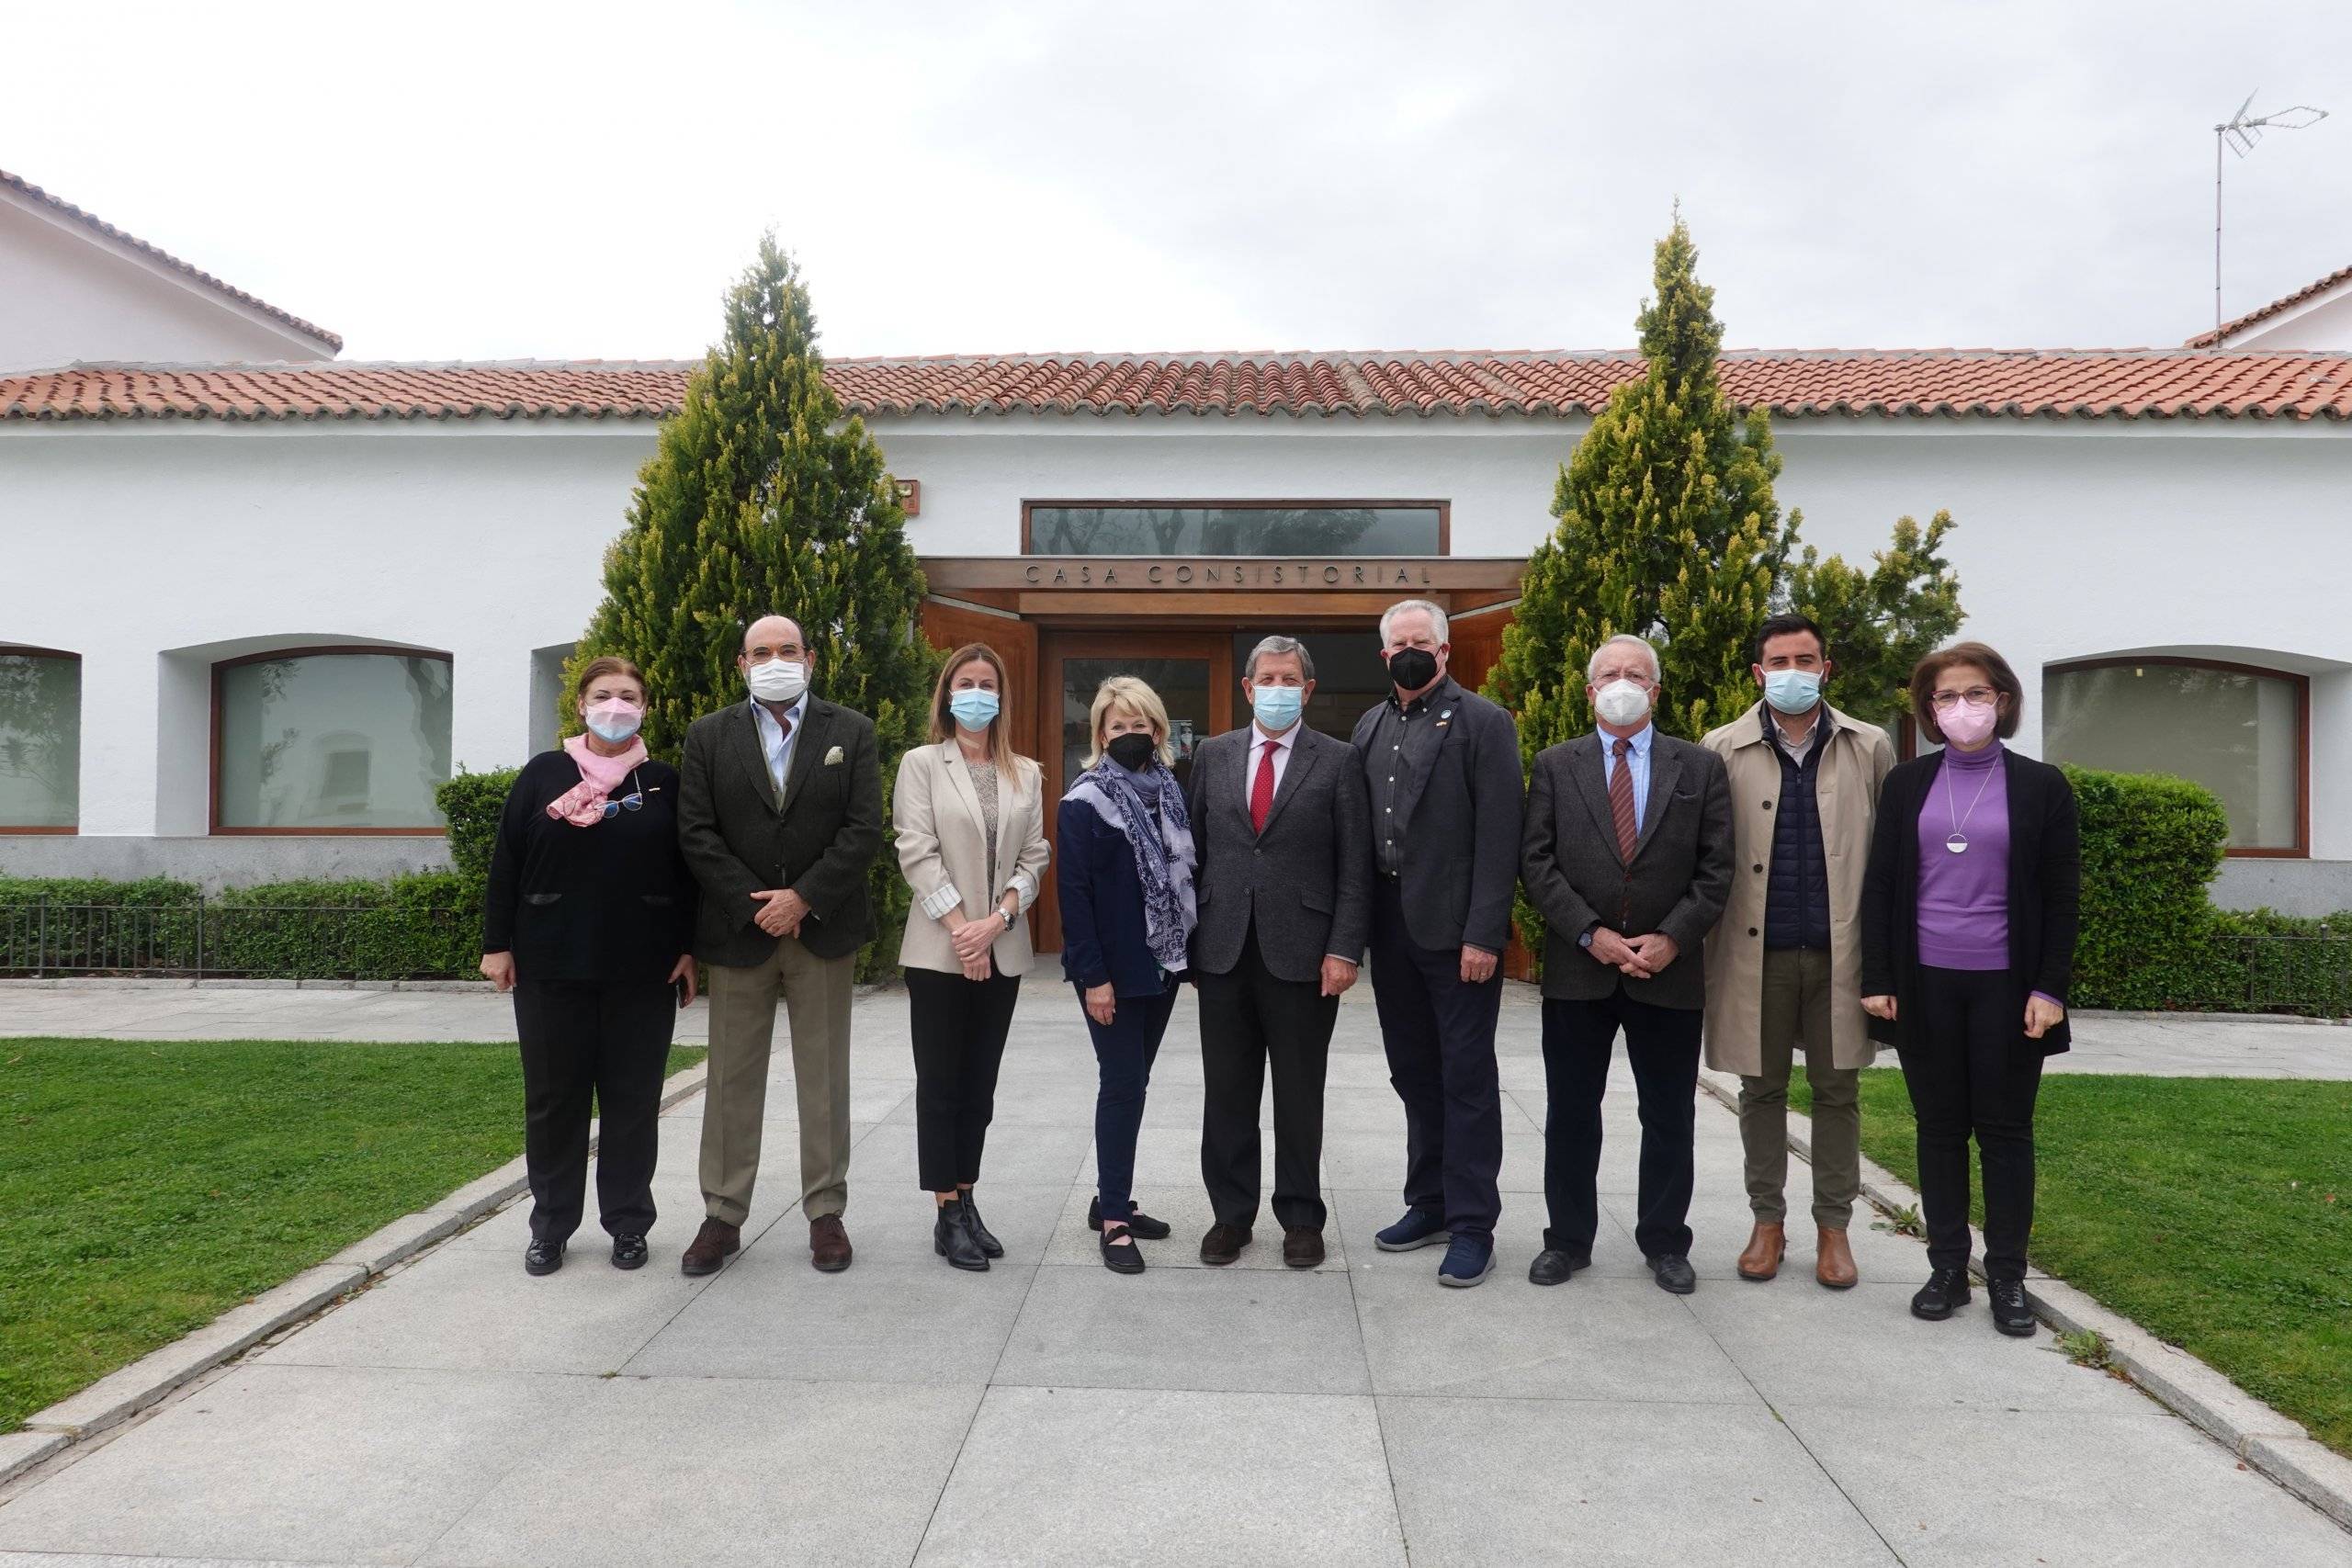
[995, 1241, 1371, 1394]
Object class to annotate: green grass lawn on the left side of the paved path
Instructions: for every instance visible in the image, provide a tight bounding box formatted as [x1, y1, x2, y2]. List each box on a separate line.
[0, 1039, 703, 1432]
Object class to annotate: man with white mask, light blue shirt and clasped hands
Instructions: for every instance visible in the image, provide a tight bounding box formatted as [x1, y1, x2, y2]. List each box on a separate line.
[1520, 637, 1731, 1295]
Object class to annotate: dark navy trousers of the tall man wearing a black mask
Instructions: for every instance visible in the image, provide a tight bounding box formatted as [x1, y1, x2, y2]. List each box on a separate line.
[1371, 877, 1503, 1236]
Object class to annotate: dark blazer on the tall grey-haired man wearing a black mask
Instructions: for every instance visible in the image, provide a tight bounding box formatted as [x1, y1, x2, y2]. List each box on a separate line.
[1355, 674, 1526, 952]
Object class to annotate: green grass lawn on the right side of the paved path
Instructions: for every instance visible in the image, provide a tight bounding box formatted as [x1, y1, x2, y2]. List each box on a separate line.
[1790, 1067, 2352, 1455]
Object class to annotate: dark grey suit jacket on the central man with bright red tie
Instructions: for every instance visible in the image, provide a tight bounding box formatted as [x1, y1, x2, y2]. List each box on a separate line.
[1190, 722, 1371, 983]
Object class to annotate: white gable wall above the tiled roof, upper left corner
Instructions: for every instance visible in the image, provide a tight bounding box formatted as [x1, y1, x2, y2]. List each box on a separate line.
[0, 188, 332, 374]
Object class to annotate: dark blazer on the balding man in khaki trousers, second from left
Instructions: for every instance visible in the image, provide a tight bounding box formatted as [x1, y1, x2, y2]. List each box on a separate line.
[677, 694, 882, 968]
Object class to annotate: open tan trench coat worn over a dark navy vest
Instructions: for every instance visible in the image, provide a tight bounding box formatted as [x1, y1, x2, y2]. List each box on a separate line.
[1701, 703, 1895, 1077]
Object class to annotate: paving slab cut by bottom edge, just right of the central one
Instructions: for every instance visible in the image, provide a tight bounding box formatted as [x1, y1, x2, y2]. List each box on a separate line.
[1381, 1394, 1900, 1568]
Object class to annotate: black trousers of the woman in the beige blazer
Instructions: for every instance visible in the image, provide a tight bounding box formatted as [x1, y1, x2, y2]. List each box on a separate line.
[906, 968, 1021, 1192]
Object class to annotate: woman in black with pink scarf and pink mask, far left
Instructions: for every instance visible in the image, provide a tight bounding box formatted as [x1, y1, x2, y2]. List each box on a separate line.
[482, 659, 696, 1274]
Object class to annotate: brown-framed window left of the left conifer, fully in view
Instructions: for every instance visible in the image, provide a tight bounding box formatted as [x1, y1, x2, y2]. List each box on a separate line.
[214, 651, 449, 832]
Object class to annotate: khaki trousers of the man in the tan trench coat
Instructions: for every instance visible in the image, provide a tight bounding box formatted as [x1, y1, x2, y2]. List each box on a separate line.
[1740, 947, 1863, 1229]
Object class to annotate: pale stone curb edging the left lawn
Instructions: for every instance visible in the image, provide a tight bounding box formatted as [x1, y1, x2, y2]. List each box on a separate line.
[14, 1063, 708, 1481]
